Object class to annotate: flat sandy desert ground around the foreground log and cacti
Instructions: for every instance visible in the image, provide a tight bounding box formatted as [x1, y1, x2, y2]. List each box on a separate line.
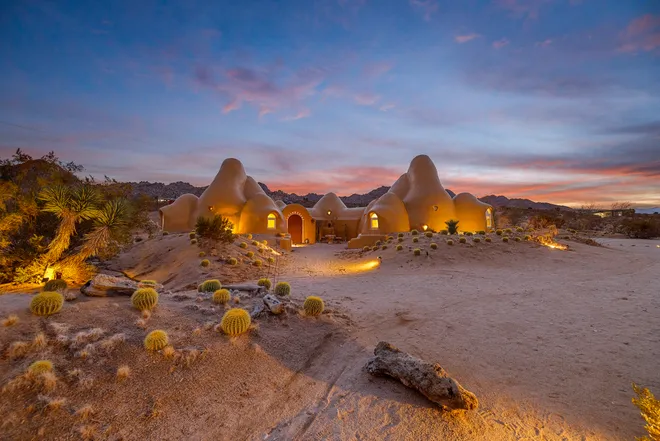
[0, 232, 660, 441]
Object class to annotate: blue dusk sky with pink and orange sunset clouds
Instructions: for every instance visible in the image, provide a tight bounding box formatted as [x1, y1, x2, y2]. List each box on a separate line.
[0, 0, 660, 207]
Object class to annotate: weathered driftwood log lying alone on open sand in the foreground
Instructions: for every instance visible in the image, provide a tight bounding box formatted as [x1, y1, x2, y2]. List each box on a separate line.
[365, 341, 479, 410]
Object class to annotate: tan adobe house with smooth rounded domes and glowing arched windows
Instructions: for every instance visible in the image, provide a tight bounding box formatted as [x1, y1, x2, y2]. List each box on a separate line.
[160, 155, 494, 249]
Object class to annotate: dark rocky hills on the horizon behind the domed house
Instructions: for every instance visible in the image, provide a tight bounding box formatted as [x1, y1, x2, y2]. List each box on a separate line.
[131, 181, 570, 210]
